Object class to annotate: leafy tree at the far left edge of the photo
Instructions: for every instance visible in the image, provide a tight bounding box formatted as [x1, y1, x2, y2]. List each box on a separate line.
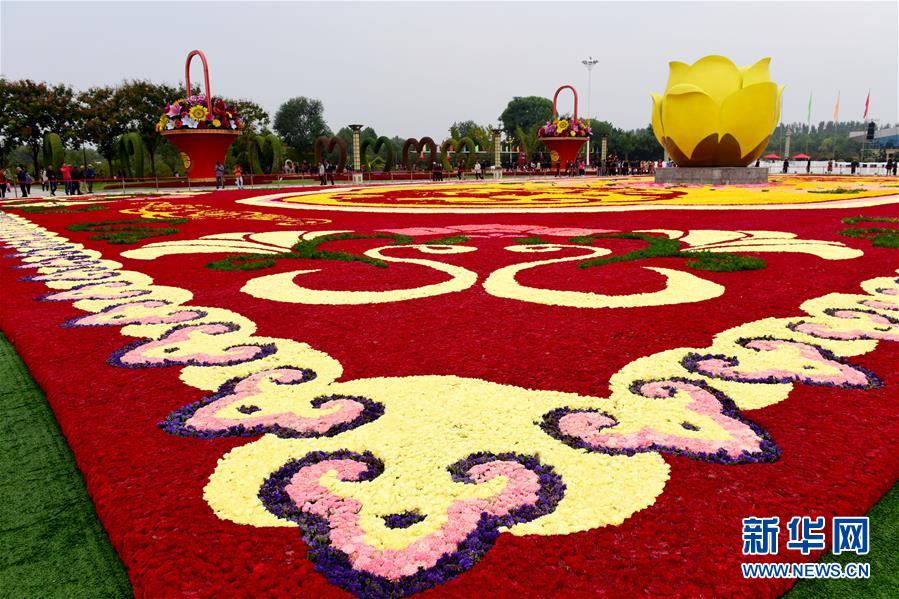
[0, 79, 79, 170]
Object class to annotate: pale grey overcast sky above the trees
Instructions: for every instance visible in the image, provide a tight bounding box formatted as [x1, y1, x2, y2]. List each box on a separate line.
[0, 0, 899, 137]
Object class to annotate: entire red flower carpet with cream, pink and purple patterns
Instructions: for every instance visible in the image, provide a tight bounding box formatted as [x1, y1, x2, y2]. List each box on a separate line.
[0, 177, 899, 597]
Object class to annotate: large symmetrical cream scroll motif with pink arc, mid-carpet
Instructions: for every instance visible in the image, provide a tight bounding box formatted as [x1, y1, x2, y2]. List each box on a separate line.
[122, 224, 862, 308]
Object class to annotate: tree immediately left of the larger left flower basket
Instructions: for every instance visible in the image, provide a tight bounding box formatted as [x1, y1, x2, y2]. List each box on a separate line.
[116, 81, 181, 175]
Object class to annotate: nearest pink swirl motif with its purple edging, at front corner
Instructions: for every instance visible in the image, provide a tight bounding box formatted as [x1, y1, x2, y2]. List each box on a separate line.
[259, 450, 565, 597]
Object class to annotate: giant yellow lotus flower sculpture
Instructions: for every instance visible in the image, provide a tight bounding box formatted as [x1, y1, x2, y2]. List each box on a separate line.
[652, 56, 783, 166]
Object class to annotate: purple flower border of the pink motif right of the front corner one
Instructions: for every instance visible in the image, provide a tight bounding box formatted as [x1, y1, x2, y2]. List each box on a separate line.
[539, 377, 780, 464]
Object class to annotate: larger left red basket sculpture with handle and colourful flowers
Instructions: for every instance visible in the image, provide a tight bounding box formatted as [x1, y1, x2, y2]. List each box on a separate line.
[156, 50, 241, 179]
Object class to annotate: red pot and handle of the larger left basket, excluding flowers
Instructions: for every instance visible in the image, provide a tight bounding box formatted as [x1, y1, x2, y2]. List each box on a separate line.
[160, 50, 240, 179]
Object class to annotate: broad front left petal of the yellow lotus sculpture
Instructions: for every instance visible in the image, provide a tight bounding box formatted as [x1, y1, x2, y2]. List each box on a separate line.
[661, 91, 718, 157]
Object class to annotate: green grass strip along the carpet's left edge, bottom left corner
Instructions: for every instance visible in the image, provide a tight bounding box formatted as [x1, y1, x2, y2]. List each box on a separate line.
[0, 333, 133, 599]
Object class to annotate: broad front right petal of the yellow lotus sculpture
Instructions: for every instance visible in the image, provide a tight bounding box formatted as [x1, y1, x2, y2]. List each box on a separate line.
[719, 82, 777, 155]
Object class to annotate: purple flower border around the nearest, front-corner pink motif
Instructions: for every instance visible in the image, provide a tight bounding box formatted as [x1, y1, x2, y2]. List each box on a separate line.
[259, 449, 565, 599]
